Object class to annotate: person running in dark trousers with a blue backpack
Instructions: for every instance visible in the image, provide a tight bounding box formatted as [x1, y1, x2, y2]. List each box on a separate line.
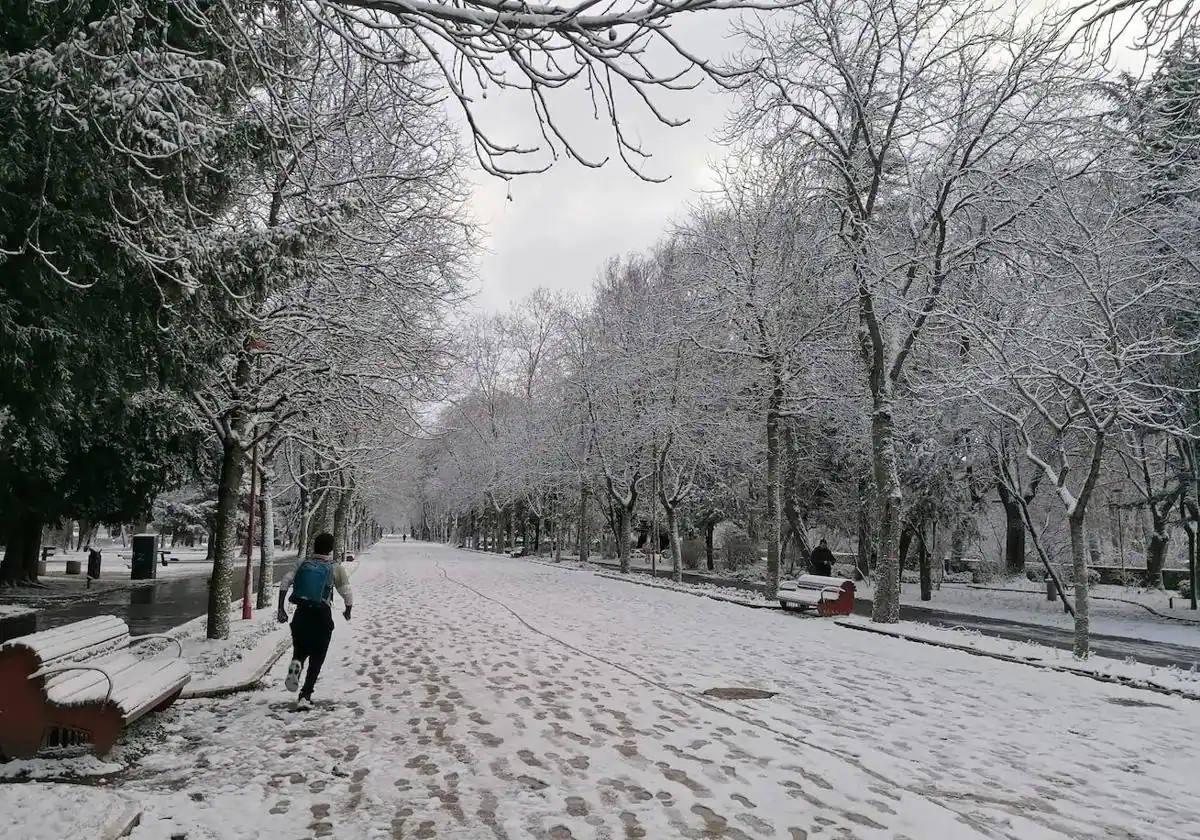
[277, 533, 354, 709]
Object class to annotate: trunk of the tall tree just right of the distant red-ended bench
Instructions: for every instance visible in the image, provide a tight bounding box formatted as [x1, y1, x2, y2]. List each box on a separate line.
[871, 396, 904, 624]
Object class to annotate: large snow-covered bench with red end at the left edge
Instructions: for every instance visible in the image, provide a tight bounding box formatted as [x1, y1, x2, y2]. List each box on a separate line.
[0, 616, 191, 758]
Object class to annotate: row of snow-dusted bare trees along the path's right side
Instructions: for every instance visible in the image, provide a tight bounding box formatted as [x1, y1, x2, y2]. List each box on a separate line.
[410, 0, 1200, 655]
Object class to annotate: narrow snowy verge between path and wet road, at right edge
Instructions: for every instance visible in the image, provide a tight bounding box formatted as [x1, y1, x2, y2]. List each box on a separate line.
[836, 616, 1200, 700]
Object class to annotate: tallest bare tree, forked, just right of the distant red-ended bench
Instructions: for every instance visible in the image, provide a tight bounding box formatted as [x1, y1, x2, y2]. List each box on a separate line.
[733, 0, 1099, 622]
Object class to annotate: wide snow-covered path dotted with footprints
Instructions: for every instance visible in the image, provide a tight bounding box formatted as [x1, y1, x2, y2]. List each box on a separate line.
[115, 542, 1200, 840]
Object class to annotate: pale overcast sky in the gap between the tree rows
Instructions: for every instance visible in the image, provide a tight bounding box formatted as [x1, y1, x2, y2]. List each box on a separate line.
[458, 13, 732, 311]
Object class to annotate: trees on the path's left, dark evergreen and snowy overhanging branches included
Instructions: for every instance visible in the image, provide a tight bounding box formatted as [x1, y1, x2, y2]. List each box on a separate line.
[0, 0, 758, 636]
